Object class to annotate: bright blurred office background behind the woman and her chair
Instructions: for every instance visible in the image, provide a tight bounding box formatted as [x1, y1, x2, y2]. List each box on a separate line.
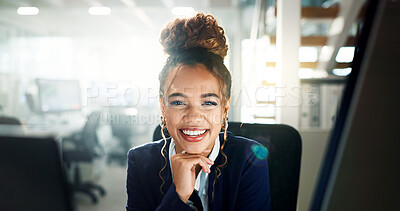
[0, 0, 364, 211]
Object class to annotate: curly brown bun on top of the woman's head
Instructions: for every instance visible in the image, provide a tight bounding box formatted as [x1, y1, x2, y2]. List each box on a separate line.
[160, 13, 228, 58]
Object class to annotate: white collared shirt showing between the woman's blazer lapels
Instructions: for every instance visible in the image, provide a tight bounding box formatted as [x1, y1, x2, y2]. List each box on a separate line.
[169, 136, 220, 211]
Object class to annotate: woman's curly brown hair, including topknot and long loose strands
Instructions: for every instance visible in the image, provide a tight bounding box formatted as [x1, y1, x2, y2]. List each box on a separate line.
[159, 13, 232, 199]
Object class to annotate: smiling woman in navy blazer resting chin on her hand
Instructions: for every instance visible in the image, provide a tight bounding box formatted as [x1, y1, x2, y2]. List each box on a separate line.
[126, 13, 270, 211]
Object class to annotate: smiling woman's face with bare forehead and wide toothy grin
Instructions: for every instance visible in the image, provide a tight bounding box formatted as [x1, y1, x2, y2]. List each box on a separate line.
[160, 64, 229, 155]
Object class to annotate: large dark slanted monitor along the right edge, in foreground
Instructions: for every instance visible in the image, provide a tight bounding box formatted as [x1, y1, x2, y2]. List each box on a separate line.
[310, 0, 400, 211]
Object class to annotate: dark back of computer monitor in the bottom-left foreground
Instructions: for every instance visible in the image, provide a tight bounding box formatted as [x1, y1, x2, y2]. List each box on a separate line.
[0, 135, 73, 211]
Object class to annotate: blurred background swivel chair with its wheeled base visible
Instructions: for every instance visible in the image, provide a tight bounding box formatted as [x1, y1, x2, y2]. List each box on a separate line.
[62, 112, 106, 203]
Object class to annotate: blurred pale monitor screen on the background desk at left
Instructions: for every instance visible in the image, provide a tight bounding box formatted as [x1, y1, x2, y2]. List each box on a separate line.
[36, 79, 82, 112]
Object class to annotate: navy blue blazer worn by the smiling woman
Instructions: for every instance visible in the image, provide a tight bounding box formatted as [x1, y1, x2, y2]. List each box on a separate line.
[126, 133, 271, 211]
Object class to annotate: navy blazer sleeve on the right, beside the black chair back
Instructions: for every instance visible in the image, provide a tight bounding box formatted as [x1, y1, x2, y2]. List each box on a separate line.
[235, 145, 271, 211]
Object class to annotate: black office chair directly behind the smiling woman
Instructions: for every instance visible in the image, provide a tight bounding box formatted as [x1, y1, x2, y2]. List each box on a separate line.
[153, 122, 302, 211]
